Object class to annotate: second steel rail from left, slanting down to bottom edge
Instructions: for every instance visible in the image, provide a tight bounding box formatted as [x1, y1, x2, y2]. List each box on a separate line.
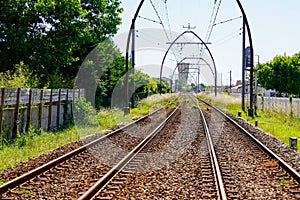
[79, 104, 181, 200]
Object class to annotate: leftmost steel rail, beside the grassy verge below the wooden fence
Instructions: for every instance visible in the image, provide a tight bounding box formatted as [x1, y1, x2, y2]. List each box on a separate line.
[0, 108, 163, 193]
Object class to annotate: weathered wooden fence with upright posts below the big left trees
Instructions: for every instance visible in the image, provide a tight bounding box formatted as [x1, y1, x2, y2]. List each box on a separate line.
[0, 88, 85, 140]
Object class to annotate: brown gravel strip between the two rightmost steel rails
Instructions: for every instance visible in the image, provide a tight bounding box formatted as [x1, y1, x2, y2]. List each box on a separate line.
[200, 97, 300, 199]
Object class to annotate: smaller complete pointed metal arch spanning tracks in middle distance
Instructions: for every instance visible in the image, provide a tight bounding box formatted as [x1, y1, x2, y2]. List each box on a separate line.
[159, 30, 217, 96]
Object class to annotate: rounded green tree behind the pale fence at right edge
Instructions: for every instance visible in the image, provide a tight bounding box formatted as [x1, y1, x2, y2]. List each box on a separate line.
[256, 53, 300, 95]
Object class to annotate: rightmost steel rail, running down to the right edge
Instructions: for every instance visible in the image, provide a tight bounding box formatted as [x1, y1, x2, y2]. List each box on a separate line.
[199, 99, 300, 183]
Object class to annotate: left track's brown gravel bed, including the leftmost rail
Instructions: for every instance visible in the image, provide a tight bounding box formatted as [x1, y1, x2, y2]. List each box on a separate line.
[0, 109, 170, 199]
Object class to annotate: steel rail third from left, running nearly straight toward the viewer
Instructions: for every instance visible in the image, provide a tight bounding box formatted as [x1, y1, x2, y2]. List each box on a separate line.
[192, 95, 227, 200]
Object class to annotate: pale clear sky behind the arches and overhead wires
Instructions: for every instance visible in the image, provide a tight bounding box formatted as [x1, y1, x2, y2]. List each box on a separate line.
[115, 0, 300, 85]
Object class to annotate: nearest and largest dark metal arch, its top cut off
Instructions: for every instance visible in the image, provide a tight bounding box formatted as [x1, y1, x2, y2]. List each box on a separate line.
[124, 0, 254, 116]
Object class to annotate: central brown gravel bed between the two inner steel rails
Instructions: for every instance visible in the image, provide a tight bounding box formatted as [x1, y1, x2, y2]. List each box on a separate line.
[87, 96, 226, 199]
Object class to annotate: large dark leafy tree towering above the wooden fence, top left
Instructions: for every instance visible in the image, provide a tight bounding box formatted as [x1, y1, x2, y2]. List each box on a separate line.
[0, 0, 122, 87]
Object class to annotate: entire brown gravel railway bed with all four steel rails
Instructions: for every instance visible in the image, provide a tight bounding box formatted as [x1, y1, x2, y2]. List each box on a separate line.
[0, 95, 300, 200]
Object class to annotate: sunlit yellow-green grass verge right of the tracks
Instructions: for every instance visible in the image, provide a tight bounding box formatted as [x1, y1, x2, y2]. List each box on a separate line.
[197, 95, 300, 150]
